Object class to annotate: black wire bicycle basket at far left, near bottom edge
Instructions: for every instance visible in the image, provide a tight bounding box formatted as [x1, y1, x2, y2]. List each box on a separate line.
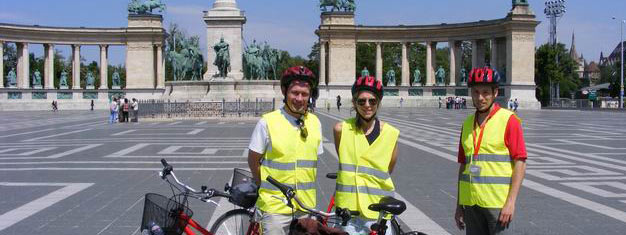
[141, 193, 193, 235]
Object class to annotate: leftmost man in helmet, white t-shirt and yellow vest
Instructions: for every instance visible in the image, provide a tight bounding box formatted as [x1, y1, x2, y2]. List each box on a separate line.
[248, 66, 324, 235]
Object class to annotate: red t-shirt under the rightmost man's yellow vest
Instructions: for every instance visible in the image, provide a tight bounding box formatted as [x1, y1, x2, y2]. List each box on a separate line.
[457, 104, 528, 164]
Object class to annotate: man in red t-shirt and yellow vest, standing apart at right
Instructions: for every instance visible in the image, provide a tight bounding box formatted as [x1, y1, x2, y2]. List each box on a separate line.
[454, 67, 527, 235]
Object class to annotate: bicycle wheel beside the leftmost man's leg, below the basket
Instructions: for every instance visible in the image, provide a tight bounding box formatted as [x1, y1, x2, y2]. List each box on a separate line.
[206, 209, 252, 235]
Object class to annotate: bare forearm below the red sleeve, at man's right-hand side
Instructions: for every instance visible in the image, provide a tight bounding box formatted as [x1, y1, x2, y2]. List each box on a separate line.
[498, 160, 526, 227]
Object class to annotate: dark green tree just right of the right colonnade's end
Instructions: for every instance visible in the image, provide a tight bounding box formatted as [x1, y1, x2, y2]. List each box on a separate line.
[535, 43, 582, 106]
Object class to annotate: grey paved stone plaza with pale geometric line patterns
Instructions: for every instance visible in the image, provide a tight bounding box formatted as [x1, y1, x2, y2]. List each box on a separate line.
[0, 109, 626, 234]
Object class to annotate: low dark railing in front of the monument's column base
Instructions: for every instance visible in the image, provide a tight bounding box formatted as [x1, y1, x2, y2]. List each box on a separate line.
[138, 99, 276, 118]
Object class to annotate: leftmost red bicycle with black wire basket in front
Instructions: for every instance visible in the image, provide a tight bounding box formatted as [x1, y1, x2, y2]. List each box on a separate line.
[140, 159, 260, 235]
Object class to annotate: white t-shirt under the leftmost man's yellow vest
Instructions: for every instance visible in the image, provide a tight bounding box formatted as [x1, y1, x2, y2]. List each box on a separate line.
[248, 108, 324, 155]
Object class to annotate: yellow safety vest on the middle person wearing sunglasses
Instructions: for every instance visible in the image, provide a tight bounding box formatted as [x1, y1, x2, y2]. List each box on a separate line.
[335, 118, 400, 219]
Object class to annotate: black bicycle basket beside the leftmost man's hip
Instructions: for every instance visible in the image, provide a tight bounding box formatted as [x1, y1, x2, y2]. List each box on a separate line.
[228, 168, 259, 208]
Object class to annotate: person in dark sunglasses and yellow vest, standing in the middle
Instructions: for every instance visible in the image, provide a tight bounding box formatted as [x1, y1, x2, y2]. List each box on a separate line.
[334, 76, 400, 234]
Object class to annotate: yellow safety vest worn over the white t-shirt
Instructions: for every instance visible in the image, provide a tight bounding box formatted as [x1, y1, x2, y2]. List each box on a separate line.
[256, 110, 322, 214]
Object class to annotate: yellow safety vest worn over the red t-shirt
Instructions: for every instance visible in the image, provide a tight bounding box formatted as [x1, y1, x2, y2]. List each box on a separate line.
[459, 108, 515, 208]
